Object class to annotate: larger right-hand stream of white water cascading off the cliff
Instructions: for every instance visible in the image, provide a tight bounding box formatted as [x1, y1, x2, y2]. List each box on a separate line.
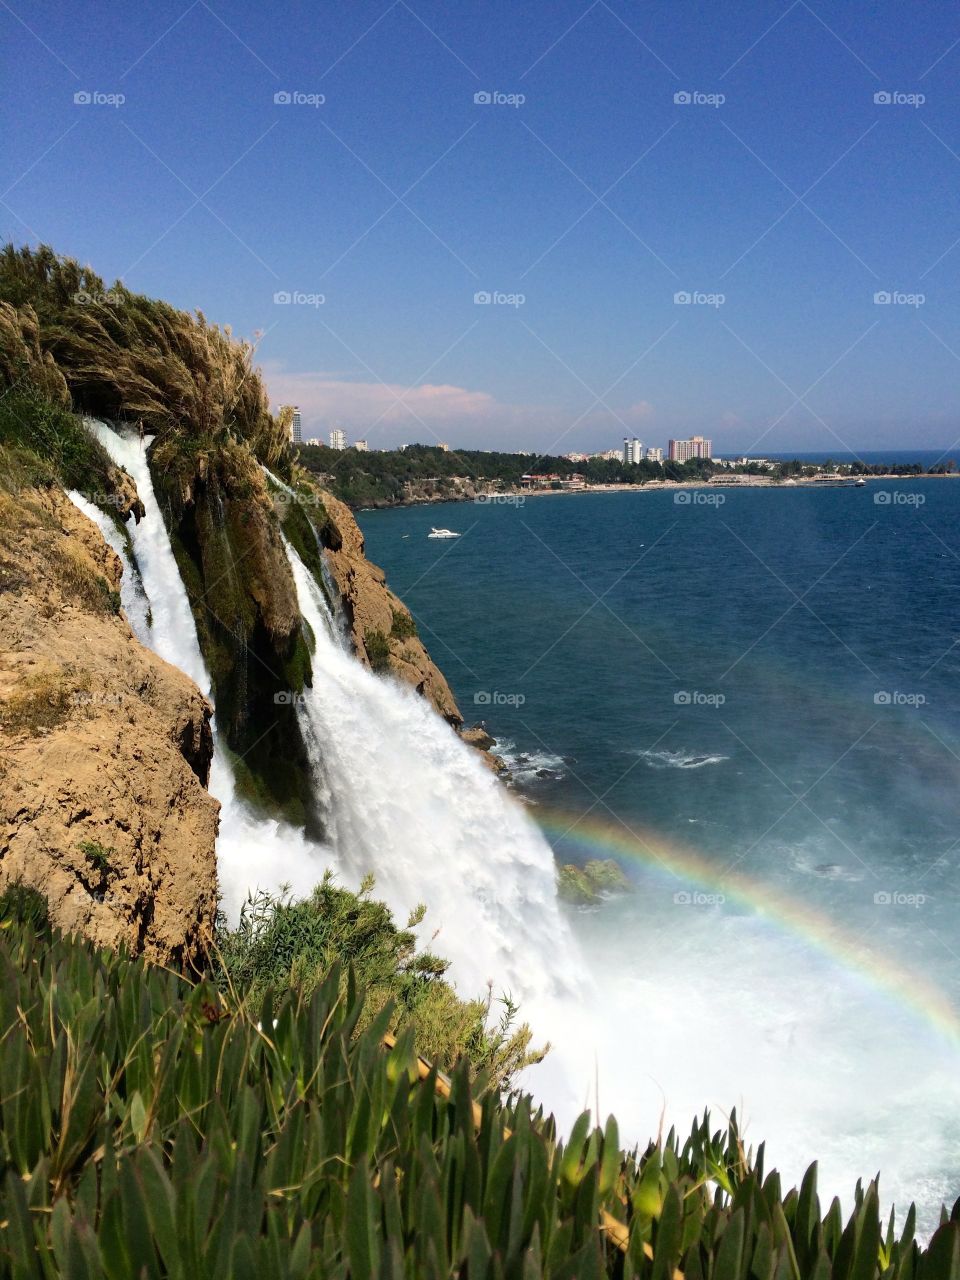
[287, 529, 593, 1121]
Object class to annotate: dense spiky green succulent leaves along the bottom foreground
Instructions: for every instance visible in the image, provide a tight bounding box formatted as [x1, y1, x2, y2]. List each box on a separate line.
[0, 892, 960, 1280]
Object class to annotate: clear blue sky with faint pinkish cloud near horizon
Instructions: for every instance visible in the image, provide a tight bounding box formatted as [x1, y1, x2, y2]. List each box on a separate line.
[0, 0, 960, 454]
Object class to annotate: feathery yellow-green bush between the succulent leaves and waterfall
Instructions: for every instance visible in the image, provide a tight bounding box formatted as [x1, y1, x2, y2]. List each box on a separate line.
[216, 872, 544, 1093]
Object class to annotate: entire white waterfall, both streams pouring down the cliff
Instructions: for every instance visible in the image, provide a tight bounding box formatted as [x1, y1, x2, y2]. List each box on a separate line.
[78, 422, 593, 1123]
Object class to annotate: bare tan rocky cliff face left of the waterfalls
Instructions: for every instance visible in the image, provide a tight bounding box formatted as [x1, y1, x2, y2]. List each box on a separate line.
[0, 489, 219, 965]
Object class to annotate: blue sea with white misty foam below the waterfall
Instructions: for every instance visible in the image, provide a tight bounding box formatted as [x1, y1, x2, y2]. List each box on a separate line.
[358, 478, 960, 1230]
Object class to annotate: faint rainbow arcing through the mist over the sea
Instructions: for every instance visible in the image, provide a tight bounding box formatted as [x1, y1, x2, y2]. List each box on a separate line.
[532, 808, 960, 1048]
